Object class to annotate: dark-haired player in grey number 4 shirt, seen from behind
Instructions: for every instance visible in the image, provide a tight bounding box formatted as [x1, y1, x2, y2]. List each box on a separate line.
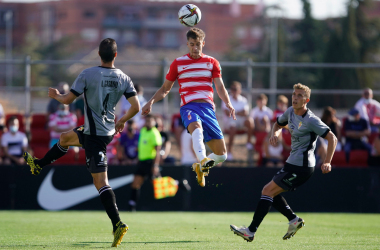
[24, 38, 140, 247]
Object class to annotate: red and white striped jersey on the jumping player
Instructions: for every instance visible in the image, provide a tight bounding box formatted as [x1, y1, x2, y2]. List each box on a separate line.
[166, 54, 222, 107]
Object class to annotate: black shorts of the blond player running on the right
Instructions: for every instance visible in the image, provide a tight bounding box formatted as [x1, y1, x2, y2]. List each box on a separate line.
[272, 163, 314, 191]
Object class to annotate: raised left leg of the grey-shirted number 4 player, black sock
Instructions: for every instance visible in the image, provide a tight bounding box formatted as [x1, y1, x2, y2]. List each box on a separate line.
[24, 127, 83, 175]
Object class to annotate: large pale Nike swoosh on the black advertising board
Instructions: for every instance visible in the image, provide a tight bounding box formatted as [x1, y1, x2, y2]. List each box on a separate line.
[37, 168, 133, 210]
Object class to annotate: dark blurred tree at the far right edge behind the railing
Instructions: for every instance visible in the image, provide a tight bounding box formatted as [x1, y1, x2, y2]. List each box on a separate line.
[323, 0, 380, 89]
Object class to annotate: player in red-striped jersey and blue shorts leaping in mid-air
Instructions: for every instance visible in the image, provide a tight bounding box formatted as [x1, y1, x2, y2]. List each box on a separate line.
[142, 28, 236, 187]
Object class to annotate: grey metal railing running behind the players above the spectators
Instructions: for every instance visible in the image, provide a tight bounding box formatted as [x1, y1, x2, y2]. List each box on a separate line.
[0, 56, 380, 119]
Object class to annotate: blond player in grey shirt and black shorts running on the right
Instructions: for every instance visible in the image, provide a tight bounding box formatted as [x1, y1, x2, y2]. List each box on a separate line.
[230, 83, 337, 242]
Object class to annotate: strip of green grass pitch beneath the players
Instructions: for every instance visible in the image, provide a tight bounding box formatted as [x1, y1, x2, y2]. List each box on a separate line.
[0, 211, 380, 250]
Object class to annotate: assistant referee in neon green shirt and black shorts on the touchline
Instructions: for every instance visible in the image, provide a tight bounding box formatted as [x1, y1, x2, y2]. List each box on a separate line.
[128, 114, 162, 211]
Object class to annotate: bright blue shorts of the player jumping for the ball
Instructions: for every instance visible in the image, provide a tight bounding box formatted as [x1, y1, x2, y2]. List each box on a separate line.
[180, 102, 224, 142]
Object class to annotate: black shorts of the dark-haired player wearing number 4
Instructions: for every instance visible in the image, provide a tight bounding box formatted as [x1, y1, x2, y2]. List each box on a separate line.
[73, 126, 113, 173]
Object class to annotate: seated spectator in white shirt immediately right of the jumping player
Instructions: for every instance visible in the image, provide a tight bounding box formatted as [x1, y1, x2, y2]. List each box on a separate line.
[222, 81, 255, 160]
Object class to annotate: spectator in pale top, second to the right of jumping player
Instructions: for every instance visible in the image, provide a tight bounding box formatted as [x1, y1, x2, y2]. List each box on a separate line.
[250, 94, 273, 133]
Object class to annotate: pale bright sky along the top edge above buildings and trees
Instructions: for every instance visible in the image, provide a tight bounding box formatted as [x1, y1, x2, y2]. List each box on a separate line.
[2, 0, 348, 19]
